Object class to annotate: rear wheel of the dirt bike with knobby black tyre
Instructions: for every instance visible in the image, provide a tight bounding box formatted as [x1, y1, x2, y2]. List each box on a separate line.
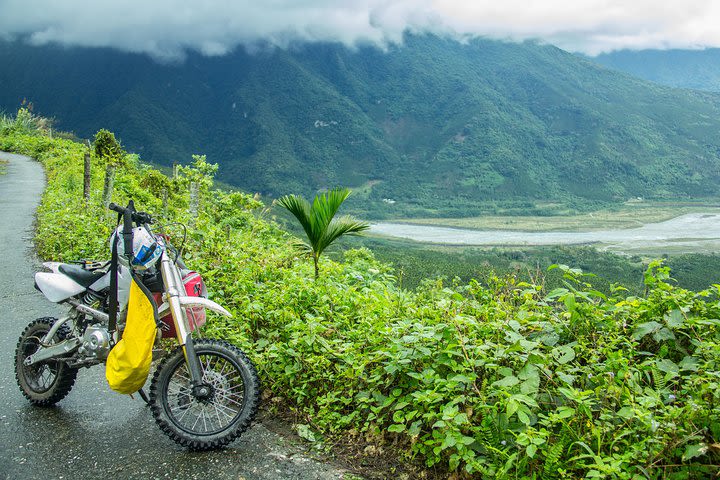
[15, 317, 77, 406]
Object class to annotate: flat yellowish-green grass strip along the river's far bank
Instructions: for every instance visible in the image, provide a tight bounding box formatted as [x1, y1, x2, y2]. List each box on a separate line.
[392, 202, 720, 232]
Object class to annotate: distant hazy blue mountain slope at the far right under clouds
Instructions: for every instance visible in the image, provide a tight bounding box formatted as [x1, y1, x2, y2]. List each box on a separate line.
[592, 48, 720, 92]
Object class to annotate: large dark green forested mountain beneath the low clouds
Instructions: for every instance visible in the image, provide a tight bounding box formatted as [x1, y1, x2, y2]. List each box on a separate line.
[0, 36, 720, 216]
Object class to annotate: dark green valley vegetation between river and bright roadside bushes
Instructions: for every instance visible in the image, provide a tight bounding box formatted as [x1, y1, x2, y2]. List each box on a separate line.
[354, 237, 720, 295]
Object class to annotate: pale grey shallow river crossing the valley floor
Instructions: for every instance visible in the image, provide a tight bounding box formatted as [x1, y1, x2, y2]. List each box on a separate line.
[370, 213, 720, 254]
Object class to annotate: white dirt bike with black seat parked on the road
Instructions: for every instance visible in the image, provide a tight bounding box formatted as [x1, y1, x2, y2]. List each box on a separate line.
[15, 201, 260, 450]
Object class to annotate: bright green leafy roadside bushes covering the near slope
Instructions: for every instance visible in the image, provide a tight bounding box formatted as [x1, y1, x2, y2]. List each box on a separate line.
[0, 112, 720, 479]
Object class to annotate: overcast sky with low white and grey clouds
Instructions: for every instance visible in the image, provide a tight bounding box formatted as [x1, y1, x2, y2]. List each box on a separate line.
[0, 0, 720, 59]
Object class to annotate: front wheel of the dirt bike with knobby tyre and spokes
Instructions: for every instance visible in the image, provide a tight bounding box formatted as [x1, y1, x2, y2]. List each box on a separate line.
[150, 339, 260, 450]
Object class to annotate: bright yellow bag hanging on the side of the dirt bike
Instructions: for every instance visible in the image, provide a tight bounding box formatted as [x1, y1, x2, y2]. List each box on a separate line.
[105, 280, 157, 394]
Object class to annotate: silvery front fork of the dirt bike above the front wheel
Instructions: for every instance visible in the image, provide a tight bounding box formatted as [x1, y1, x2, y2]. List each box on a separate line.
[160, 252, 210, 398]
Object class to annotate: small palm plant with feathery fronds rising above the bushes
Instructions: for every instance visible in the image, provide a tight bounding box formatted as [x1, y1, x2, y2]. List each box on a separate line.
[277, 188, 370, 280]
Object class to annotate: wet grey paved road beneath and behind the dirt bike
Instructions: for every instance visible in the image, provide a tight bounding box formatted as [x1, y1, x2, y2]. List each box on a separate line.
[0, 153, 354, 480]
